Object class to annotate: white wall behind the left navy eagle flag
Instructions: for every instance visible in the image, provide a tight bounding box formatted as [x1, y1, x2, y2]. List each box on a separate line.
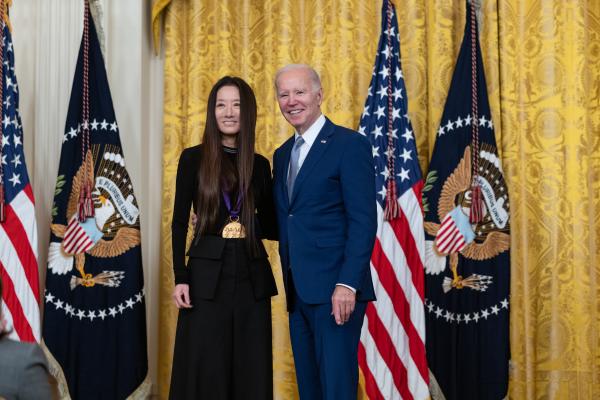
[10, 0, 163, 392]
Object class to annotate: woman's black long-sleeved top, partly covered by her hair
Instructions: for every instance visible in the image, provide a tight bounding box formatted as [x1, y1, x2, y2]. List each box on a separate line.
[171, 145, 277, 284]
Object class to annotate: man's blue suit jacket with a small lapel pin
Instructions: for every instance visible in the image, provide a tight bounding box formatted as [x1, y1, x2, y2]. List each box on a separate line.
[273, 119, 377, 305]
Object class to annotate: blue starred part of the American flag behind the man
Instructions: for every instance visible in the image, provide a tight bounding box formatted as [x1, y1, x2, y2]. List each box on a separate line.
[358, 0, 421, 208]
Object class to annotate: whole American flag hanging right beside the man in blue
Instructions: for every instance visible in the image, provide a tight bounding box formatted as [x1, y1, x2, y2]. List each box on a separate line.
[359, 0, 429, 400]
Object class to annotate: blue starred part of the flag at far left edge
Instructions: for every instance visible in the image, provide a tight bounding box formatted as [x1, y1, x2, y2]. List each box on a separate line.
[0, 23, 29, 204]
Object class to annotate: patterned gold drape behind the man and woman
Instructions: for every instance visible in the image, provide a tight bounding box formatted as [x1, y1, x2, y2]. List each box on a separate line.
[153, 0, 600, 400]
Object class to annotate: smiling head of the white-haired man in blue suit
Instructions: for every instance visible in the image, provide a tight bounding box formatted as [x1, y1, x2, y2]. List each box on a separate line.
[277, 69, 323, 134]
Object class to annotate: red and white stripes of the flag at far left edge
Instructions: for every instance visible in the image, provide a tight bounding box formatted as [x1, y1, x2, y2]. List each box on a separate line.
[0, 185, 40, 342]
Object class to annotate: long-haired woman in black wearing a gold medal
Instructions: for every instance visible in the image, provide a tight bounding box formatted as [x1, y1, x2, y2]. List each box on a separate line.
[170, 76, 277, 400]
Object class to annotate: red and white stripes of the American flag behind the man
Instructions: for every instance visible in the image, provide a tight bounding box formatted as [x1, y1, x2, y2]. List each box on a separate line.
[358, 181, 429, 400]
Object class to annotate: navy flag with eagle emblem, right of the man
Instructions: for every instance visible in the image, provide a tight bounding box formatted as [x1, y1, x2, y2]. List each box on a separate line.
[423, 3, 510, 400]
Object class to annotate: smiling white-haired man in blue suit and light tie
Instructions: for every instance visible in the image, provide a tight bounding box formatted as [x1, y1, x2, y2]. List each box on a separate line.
[273, 64, 377, 400]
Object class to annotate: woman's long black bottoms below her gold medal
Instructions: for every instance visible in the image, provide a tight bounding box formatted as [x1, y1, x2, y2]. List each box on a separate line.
[169, 239, 273, 400]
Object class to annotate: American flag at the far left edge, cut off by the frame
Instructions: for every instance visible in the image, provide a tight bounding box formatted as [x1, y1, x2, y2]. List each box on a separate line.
[0, 22, 40, 342]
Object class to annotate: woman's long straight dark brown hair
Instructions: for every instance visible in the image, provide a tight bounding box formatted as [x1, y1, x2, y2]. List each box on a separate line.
[196, 76, 257, 254]
